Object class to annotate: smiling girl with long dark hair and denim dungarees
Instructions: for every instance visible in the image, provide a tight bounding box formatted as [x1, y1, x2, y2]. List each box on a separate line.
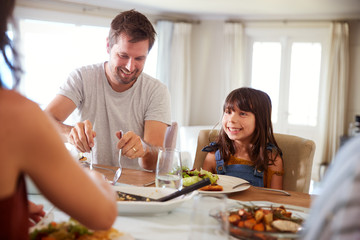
[203, 88, 283, 189]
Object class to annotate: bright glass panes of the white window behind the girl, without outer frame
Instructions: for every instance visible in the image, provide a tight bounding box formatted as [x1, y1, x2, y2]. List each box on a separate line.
[251, 41, 321, 126]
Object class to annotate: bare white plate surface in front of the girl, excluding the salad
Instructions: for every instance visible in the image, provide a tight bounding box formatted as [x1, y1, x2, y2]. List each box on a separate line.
[199, 175, 250, 194]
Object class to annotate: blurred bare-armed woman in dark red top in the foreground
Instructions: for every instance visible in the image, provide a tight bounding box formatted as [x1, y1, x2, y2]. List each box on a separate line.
[0, 0, 117, 239]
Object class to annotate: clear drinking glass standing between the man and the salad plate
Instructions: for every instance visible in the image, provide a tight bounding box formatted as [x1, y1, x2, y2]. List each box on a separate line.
[155, 148, 182, 189]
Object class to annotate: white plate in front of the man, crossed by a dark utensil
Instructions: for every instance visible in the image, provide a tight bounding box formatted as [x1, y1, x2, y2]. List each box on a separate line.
[113, 186, 196, 216]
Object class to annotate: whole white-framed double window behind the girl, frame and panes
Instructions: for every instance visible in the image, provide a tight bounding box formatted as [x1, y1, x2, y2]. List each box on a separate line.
[245, 25, 328, 175]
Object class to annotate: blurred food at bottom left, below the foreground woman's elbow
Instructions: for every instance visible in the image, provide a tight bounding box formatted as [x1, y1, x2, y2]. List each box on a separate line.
[29, 218, 134, 240]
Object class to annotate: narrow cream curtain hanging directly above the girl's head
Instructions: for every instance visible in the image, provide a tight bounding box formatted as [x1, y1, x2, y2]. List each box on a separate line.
[221, 22, 246, 99]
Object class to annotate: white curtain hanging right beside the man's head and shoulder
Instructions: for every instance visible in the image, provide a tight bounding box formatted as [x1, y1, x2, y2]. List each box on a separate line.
[157, 21, 192, 126]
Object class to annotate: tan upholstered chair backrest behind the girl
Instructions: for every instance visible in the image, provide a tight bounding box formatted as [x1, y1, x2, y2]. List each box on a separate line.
[193, 129, 315, 193]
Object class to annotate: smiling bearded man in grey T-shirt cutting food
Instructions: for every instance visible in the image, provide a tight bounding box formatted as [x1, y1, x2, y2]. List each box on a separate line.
[45, 10, 171, 170]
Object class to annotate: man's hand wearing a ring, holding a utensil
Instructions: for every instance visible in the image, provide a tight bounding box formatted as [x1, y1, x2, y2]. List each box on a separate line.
[116, 131, 146, 159]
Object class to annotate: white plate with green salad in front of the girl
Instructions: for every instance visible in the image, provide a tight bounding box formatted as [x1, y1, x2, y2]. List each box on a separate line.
[183, 169, 250, 194]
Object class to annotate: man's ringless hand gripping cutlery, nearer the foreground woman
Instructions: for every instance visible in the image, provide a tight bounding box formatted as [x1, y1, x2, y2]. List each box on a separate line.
[67, 120, 96, 152]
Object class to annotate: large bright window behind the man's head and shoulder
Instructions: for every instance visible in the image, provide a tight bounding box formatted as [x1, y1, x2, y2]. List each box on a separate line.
[19, 19, 157, 108]
